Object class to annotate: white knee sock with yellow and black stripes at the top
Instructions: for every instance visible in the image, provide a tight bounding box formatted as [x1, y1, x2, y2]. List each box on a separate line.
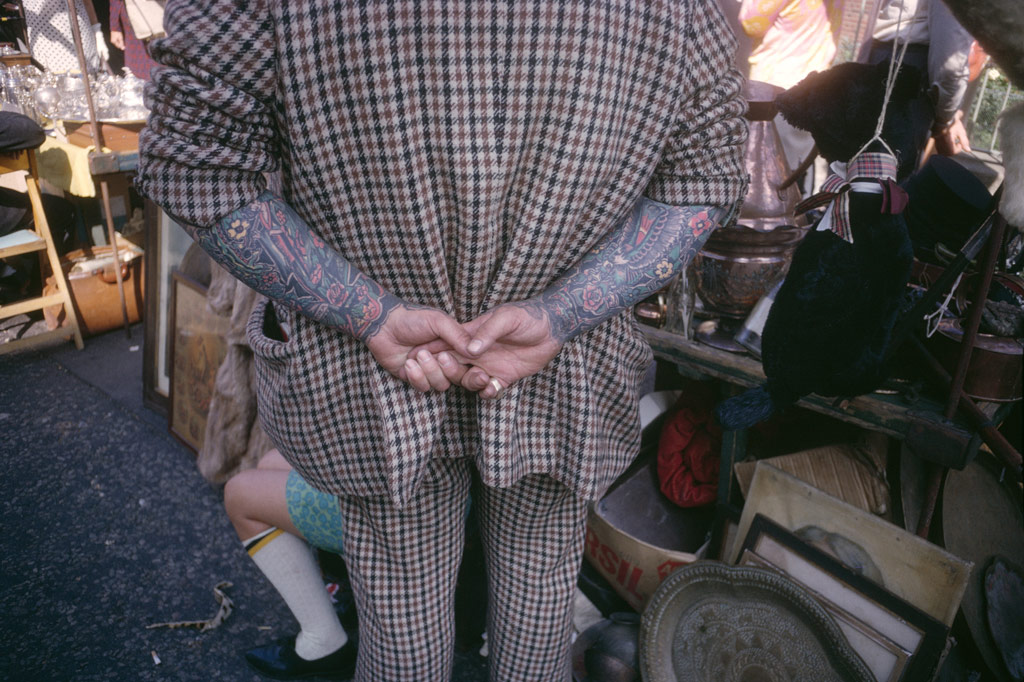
[242, 528, 348, 660]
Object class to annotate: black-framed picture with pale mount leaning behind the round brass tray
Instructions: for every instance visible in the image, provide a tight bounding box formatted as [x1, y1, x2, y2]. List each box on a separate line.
[739, 514, 948, 682]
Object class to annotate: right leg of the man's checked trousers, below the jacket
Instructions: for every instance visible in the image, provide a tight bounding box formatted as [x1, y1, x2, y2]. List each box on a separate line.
[473, 474, 587, 682]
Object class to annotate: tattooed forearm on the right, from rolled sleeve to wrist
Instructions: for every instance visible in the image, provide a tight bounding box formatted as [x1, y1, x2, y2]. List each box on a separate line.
[540, 199, 726, 342]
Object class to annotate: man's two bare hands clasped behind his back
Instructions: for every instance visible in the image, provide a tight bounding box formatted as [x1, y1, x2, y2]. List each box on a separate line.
[367, 300, 562, 399]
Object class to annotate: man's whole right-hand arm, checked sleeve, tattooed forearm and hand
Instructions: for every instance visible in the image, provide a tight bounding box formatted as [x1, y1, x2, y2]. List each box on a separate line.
[436, 2, 748, 398]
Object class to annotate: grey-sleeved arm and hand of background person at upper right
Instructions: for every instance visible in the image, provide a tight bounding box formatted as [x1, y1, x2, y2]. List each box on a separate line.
[928, 0, 974, 155]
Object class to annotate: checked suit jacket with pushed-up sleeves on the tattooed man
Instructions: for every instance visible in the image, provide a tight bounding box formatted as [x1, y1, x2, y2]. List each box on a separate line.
[138, 0, 746, 503]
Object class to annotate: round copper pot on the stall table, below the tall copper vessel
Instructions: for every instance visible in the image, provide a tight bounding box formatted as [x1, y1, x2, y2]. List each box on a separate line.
[693, 225, 807, 319]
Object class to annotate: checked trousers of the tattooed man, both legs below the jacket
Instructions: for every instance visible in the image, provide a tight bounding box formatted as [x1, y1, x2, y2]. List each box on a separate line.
[340, 459, 586, 682]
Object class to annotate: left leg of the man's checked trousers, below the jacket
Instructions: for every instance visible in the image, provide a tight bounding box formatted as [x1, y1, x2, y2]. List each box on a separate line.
[339, 460, 475, 682]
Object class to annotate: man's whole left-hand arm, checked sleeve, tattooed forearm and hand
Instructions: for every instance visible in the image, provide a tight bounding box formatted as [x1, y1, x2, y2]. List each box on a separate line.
[137, 0, 468, 390]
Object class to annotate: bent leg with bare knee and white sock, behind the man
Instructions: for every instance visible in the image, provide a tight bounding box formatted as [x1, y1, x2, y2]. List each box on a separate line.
[224, 451, 354, 663]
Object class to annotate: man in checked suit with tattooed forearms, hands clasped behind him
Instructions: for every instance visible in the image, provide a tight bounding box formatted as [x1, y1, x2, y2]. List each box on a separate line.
[138, 0, 746, 682]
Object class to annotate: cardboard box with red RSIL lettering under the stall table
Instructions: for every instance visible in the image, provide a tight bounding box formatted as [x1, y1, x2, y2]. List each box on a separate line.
[584, 432, 715, 611]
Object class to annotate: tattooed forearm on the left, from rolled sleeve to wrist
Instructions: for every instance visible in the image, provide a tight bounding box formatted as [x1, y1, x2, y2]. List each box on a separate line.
[190, 191, 400, 341]
